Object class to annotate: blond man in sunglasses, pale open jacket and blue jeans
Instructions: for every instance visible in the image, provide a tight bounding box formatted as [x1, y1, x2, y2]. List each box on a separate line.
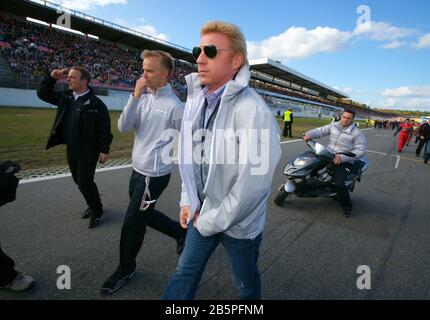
[162, 21, 281, 300]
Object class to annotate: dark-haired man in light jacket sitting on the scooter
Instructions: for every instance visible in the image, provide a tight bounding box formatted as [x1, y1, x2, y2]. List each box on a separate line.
[303, 110, 367, 218]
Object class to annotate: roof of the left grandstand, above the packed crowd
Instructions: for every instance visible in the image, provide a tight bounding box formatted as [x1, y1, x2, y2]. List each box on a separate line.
[0, 0, 195, 63]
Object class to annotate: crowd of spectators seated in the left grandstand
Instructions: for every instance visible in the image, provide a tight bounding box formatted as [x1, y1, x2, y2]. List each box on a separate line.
[0, 17, 193, 100]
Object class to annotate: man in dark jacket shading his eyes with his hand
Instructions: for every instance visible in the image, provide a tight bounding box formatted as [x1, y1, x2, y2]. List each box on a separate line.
[37, 67, 112, 228]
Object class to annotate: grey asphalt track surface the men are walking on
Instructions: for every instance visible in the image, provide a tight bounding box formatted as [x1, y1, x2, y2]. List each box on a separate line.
[0, 129, 430, 299]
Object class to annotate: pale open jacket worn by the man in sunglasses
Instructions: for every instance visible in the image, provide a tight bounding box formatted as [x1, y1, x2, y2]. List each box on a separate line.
[179, 65, 281, 239]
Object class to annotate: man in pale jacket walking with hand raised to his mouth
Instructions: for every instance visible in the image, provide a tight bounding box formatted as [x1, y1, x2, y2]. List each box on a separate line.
[101, 50, 186, 294]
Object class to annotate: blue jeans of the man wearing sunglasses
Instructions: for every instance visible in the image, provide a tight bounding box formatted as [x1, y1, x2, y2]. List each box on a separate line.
[161, 222, 263, 300]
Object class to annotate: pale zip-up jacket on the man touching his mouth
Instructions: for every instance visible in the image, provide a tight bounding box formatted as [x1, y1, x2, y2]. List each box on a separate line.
[118, 84, 184, 177]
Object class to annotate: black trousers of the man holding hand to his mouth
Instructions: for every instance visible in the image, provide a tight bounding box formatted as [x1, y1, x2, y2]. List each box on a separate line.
[118, 170, 186, 273]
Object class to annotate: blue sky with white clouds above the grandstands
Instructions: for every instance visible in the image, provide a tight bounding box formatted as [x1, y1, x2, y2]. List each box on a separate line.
[47, 0, 430, 112]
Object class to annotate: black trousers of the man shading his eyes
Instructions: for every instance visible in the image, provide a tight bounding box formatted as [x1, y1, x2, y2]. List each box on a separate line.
[67, 150, 103, 215]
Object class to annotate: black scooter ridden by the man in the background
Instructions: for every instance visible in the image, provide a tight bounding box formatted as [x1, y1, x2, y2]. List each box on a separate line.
[274, 140, 369, 206]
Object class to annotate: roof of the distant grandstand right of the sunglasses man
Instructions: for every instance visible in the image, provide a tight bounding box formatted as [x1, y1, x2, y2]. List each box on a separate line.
[250, 58, 348, 98]
